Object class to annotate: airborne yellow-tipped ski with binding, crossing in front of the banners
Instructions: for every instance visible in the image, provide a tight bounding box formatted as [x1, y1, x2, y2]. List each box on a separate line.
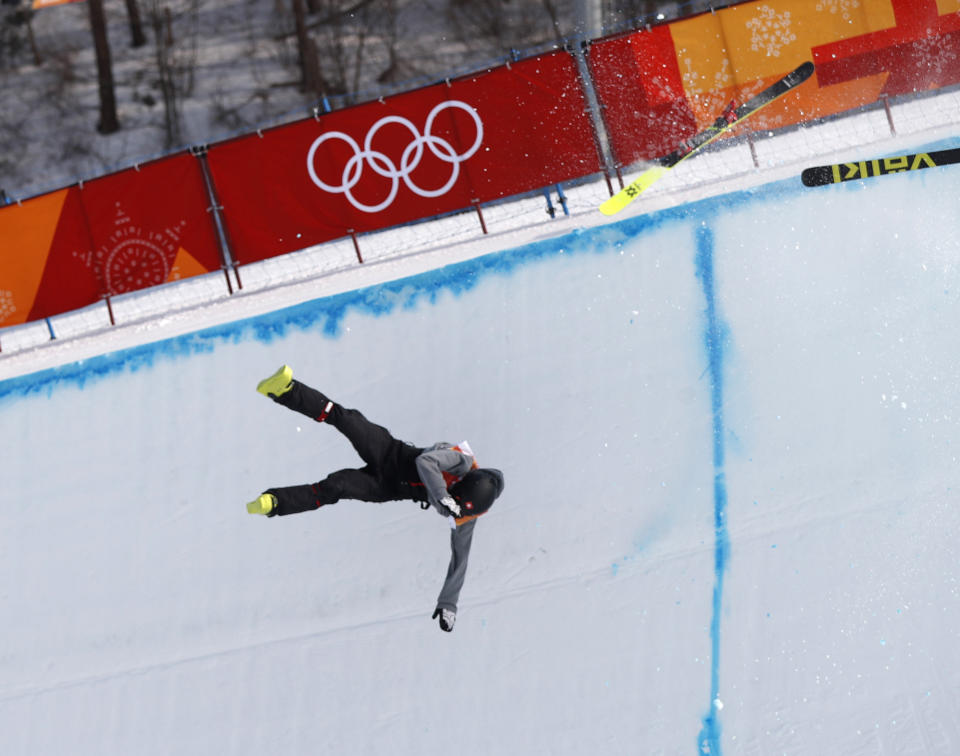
[600, 61, 813, 215]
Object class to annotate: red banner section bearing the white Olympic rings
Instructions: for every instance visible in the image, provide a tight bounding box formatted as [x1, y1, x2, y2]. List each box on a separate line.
[208, 52, 600, 262]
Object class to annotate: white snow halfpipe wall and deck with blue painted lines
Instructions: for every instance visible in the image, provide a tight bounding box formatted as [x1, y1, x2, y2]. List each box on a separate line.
[0, 101, 960, 755]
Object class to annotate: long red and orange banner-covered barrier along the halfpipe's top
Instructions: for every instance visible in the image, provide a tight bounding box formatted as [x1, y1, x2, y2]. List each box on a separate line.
[0, 0, 960, 352]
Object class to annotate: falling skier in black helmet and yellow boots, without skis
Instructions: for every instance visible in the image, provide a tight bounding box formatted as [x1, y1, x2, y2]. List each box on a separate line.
[247, 365, 503, 632]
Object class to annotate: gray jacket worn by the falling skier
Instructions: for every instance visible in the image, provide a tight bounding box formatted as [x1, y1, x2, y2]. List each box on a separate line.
[416, 443, 477, 612]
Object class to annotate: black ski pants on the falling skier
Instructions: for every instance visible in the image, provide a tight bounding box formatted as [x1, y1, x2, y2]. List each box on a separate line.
[266, 380, 425, 515]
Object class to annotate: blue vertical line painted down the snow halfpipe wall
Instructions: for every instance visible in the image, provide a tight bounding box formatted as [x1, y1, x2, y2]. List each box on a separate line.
[696, 222, 730, 756]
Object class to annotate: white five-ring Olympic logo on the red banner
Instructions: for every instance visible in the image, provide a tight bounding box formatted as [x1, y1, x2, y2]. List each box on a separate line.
[307, 100, 483, 213]
